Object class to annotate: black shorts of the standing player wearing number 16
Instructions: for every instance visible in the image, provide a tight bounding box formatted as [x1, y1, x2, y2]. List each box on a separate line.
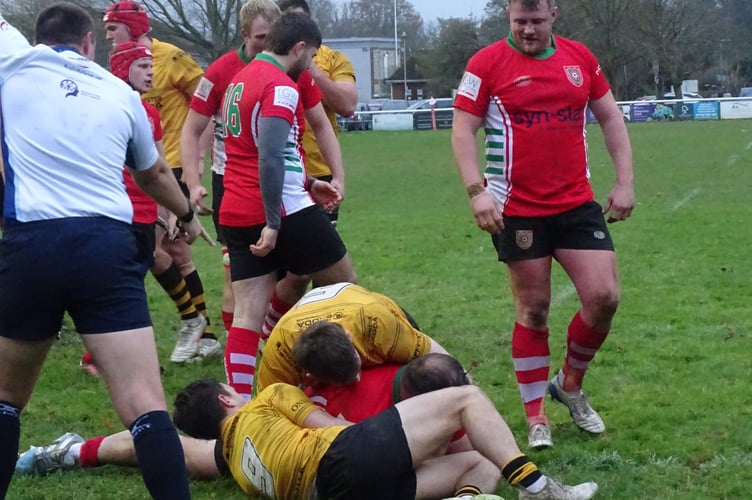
[222, 205, 347, 281]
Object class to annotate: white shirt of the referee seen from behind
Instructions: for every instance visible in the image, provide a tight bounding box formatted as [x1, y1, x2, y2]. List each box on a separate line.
[0, 15, 158, 223]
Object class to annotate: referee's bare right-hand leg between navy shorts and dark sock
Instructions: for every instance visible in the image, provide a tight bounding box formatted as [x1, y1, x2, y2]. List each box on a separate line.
[81, 327, 167, 426]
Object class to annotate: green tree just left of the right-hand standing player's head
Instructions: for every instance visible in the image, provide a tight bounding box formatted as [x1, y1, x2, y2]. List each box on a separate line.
[420, 18, 482, 96]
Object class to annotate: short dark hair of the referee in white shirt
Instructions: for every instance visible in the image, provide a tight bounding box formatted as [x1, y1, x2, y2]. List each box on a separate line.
[34, 2, 94, 45]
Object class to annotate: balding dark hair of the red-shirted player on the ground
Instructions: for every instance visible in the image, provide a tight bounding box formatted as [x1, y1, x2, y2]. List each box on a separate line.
[400, 352, 470, 397]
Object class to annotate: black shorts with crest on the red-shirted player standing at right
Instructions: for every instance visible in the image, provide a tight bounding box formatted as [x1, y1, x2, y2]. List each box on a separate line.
[491, 201, 614, 262]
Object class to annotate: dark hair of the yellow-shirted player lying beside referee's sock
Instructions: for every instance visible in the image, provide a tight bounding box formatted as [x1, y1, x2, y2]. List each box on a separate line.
[172, 380, 228, 439]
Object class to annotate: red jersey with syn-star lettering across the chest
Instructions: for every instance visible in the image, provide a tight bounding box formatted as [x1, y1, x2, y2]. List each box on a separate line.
[454, 37, 609, 217]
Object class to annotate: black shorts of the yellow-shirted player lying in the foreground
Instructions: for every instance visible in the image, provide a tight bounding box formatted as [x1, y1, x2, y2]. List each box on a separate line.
[316, 406, 416, 500]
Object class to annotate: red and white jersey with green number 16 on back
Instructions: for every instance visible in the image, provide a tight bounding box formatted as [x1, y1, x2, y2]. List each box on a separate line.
[219, 54, 322, 227]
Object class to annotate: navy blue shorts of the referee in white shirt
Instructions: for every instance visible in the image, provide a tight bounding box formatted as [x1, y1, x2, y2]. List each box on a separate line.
[0, 217, 151, 341]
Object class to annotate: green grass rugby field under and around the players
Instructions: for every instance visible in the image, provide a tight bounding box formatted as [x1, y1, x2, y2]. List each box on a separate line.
[8, 121, 752, 499]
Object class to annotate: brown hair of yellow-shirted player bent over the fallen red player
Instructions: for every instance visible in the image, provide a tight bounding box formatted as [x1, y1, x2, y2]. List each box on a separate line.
[292, 321, 360, 385]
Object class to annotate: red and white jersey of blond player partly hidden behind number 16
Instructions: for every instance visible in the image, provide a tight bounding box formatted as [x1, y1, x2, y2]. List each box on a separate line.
[190, 45, 251, 175]
